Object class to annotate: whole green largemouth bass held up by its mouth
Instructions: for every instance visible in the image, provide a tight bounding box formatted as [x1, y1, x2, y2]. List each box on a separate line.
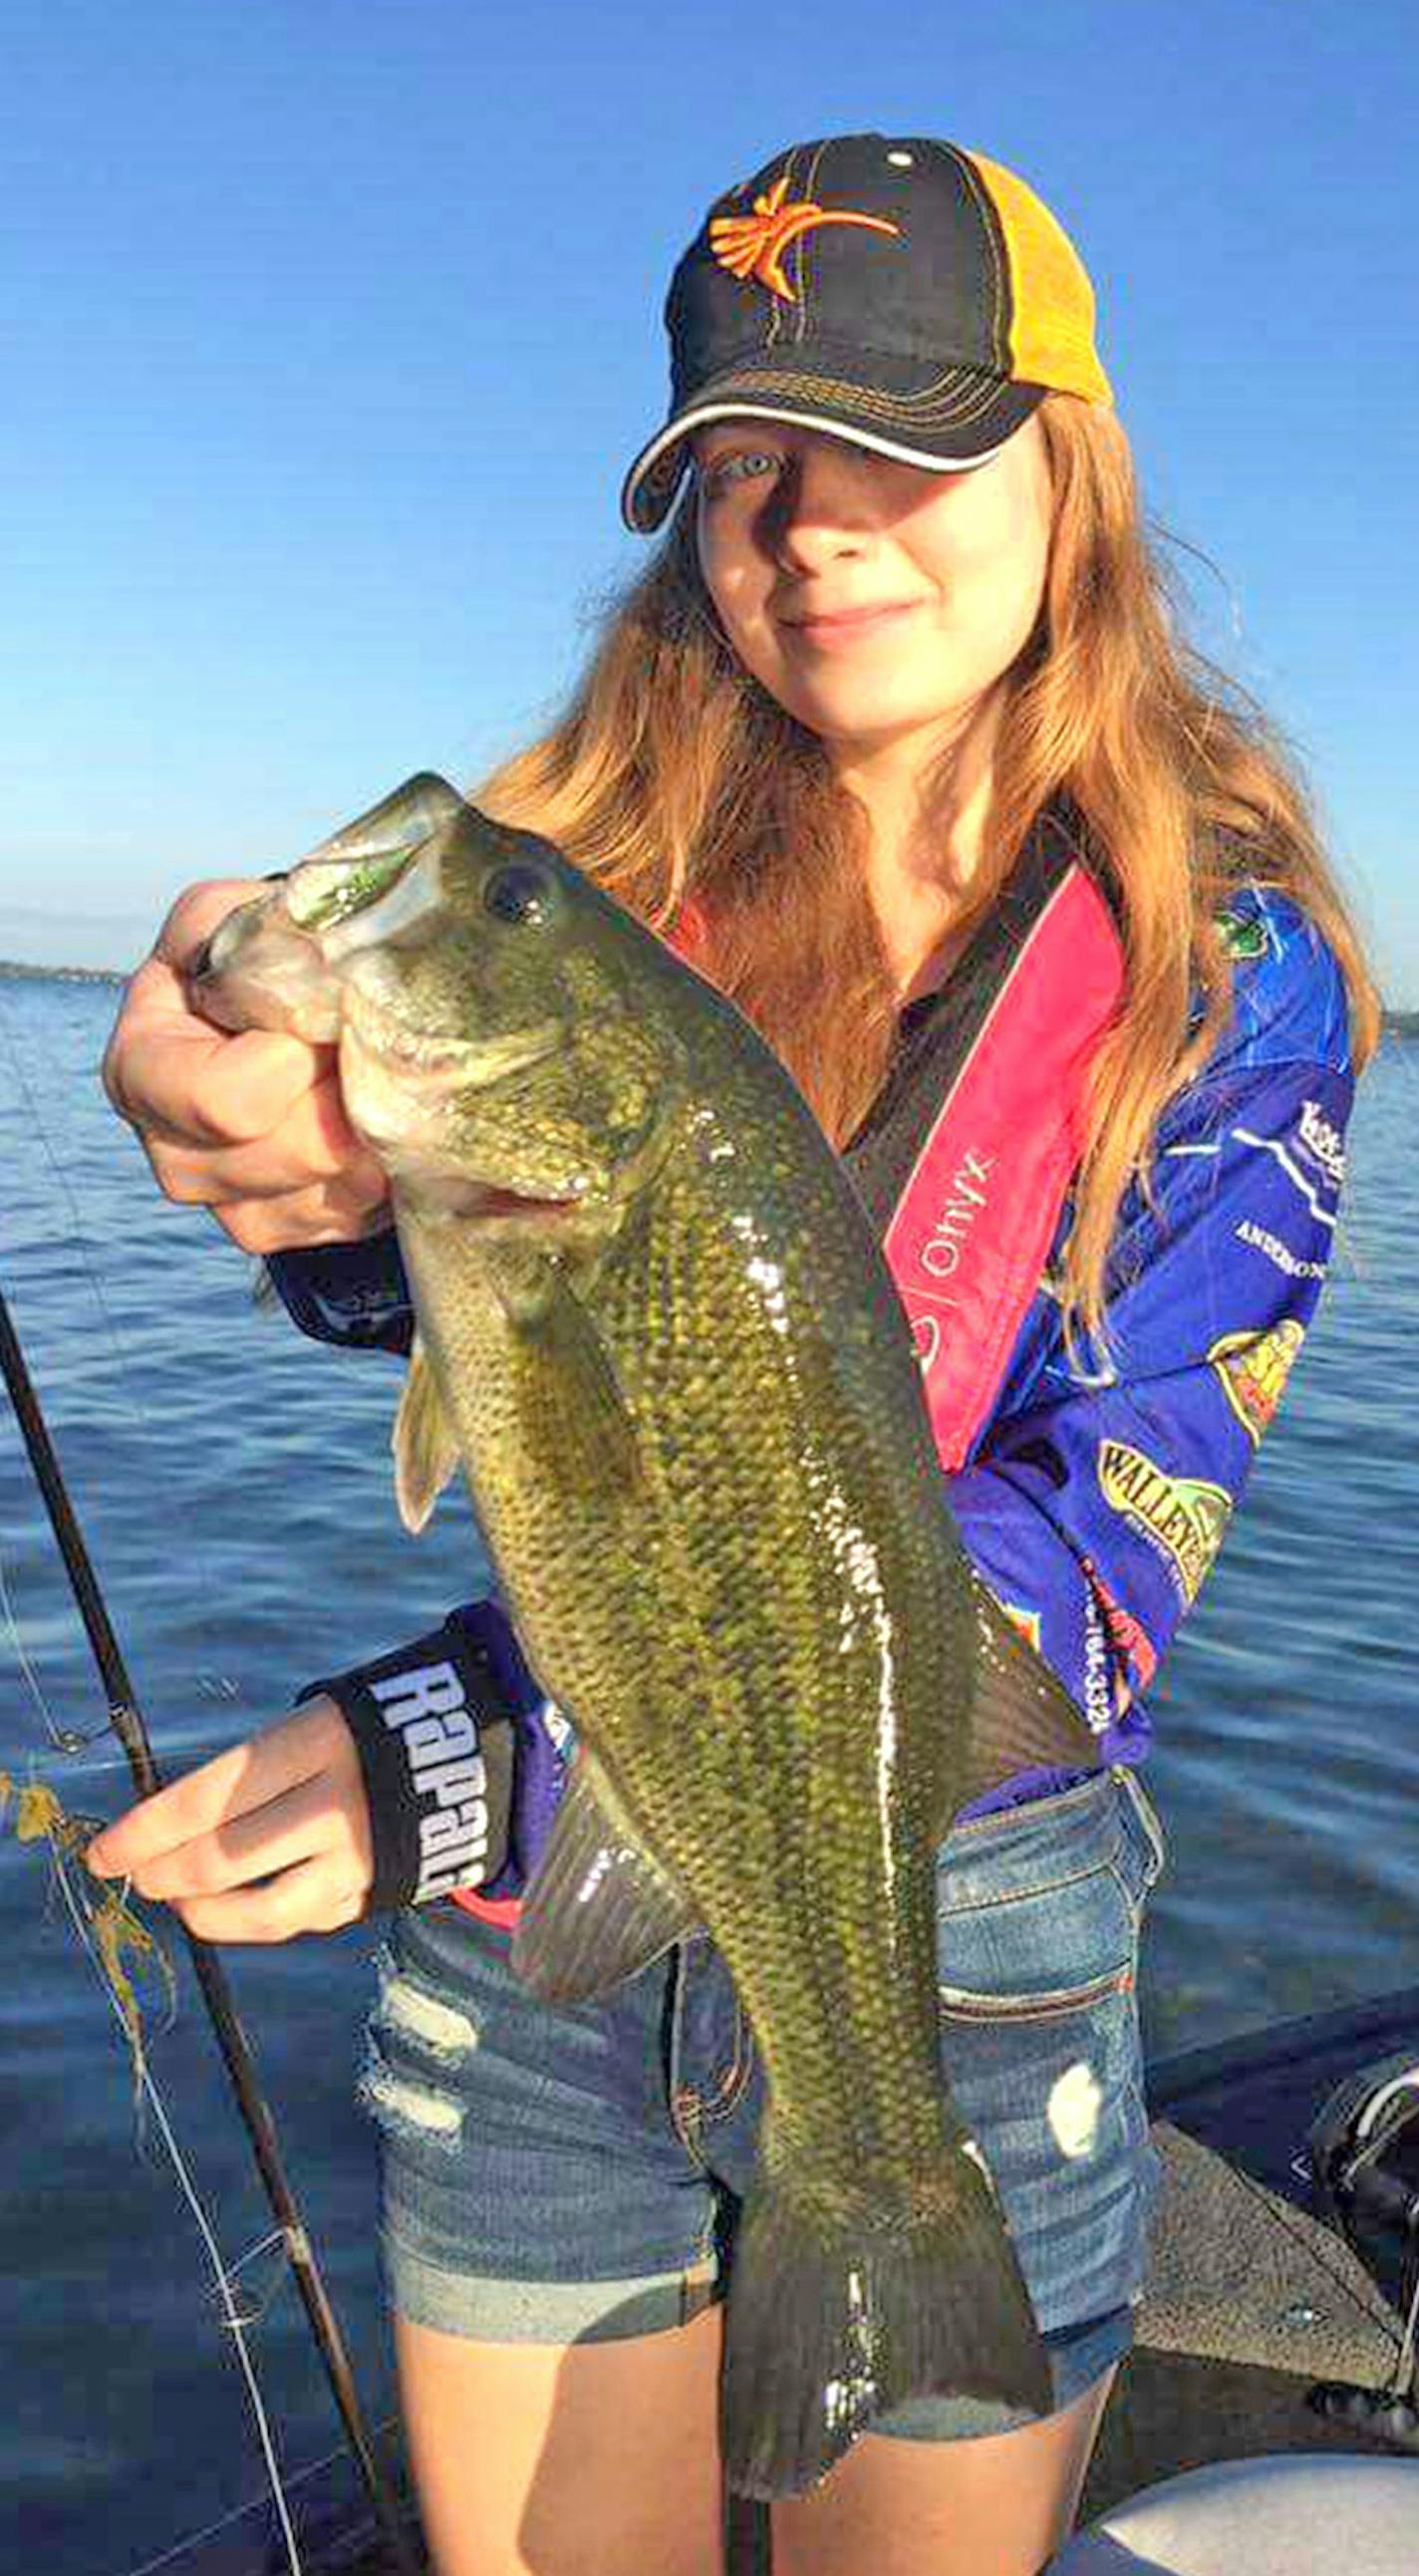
[195, 778, 1071, 2496]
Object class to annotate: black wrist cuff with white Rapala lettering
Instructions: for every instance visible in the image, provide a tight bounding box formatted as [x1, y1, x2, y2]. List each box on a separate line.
[296, 1620, 515, 1914]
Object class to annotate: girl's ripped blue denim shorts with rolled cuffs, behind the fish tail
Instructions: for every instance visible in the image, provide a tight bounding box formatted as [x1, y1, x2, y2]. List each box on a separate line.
[361, 1770, 1162, 2442]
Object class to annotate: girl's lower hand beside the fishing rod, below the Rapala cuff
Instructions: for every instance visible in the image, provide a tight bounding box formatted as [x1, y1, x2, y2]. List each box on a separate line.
[85, 1692, 374, 1942]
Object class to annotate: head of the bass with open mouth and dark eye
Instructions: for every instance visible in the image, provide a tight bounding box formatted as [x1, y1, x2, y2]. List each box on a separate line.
[190, 775, 693, 1232]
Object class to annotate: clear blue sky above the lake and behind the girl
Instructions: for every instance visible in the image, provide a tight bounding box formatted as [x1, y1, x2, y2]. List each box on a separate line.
[0, 0, 1419, 1004]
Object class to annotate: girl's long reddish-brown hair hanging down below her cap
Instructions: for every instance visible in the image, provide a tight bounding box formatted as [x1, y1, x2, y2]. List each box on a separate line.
[479, 395, 1380, 1329]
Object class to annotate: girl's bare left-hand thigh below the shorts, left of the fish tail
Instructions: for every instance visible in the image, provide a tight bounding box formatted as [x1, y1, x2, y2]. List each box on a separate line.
[394, 2308, 723, 2576]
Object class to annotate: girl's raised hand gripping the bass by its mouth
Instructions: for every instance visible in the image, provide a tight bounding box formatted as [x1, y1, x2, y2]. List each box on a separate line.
[103, 878, 389, 1252]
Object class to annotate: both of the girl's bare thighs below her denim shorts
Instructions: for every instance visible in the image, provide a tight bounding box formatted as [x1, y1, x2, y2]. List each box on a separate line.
[394, 2308, 1115, 2576]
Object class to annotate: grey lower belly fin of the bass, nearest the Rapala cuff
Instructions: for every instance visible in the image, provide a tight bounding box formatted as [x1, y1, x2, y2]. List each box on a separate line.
[512, 1744, 698, 2004]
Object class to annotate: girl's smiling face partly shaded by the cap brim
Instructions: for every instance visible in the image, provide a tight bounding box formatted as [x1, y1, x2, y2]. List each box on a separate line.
[693, 415, 1050, 757]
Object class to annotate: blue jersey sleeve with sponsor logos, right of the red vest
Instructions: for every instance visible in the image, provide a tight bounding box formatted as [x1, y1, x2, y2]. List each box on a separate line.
[951, 897, 1352, 1762]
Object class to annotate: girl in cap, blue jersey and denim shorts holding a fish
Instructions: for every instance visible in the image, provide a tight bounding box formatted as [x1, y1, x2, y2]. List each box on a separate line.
[93, 134, 1378, 2576]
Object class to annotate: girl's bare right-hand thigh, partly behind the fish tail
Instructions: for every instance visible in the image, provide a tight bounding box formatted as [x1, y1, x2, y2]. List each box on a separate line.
[772, 2370, 1112, 2576]
